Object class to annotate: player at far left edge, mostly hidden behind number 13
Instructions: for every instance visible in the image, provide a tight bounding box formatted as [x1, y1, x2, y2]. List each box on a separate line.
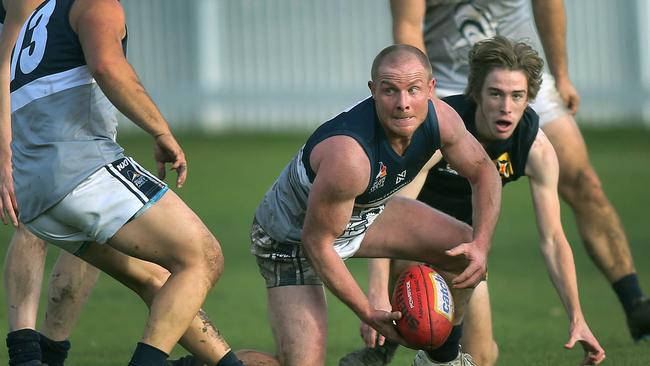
[0, 0, 99, 366]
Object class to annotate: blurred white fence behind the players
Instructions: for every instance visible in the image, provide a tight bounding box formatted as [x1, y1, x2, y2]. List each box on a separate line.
[122, 0, 650, 131]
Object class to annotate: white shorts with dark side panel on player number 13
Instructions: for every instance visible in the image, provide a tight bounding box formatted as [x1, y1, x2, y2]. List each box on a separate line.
[25, 157, 168, 255]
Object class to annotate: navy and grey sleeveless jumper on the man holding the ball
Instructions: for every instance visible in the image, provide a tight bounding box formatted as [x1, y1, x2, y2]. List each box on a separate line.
[255, 97, 440, 253]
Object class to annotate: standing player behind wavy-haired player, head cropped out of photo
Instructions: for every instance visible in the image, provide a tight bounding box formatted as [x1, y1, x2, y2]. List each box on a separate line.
[390, 0, 650, 341]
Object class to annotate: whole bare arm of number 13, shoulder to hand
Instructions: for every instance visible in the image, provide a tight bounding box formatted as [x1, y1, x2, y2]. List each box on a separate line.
[70, 0, 187, 187]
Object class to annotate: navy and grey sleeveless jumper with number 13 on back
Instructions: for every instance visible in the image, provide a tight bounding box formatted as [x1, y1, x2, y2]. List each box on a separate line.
[11, 0, 126, 222]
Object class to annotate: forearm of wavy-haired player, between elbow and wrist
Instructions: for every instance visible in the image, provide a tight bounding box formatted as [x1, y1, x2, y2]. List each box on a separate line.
[542, 234, 583, 322]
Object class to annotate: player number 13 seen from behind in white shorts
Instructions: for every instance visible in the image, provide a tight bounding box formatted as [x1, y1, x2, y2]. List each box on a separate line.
[2, 0, 241, 365]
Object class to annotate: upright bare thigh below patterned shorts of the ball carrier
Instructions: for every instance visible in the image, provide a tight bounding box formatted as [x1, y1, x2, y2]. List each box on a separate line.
[268, 285, 327, 366]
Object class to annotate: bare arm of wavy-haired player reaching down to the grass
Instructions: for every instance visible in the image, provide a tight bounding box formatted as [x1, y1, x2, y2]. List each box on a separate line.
[526, 130, 605, 364]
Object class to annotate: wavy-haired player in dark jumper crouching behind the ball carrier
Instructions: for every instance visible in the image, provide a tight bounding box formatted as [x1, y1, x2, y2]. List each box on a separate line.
[340, 36, 605, 366]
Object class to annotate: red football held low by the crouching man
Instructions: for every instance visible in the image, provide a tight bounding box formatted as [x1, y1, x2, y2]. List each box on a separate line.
[391, 264, 454, 350]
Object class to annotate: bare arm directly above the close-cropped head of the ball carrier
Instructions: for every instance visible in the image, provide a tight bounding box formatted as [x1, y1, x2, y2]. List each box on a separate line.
[390, 0, 426, 53]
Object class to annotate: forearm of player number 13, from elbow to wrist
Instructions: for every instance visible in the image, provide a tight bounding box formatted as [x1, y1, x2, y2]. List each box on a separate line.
[91, 60, 170, 137]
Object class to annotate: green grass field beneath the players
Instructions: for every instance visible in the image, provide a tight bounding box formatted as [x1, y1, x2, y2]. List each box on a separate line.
[0, 129, 650, 366]
